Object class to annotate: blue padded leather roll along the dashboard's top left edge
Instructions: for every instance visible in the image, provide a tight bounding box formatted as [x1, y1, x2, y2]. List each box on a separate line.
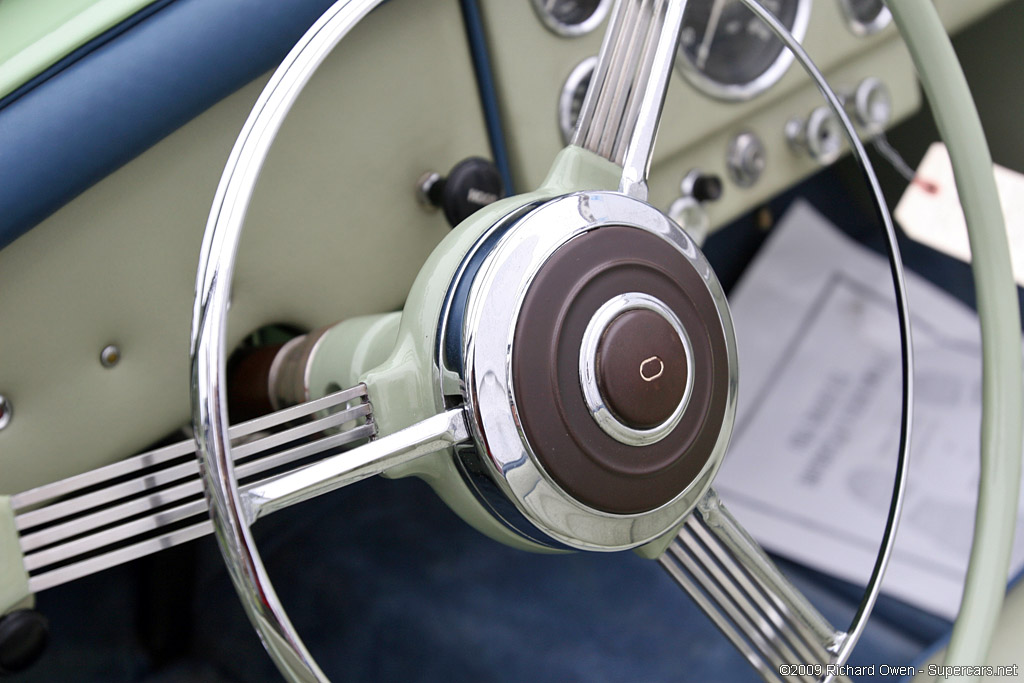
[0, 0, 332, 248]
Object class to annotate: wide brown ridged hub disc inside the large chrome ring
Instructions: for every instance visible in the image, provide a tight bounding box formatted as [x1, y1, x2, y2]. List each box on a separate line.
[511, 225, 730, 514]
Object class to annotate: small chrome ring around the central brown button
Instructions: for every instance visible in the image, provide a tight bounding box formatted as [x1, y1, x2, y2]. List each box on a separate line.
[580, 292, 693, 445]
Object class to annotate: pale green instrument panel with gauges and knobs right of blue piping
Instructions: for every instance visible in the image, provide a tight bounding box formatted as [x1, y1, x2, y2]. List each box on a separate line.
[481, 0, 1005, 226]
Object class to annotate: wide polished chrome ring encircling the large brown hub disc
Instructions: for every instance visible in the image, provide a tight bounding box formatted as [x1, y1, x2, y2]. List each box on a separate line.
[452, 191, 738, 551]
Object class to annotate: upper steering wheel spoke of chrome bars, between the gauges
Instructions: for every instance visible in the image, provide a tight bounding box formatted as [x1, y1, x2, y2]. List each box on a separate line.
[572, 0, 685, 199]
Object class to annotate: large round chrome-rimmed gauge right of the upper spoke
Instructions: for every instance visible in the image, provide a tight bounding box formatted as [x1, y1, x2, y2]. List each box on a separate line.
[676, 0, 811, 99]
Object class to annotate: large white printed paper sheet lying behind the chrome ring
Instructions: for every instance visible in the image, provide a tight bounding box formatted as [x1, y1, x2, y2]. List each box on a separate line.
[715, 203, 1024, 617]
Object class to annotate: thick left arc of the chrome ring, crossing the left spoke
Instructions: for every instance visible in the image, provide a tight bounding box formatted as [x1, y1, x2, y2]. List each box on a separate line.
[191, 0, 384, 682]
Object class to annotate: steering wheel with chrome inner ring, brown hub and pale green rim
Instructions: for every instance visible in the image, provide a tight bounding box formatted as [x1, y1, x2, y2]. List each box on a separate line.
[191, 0, 1022, 681]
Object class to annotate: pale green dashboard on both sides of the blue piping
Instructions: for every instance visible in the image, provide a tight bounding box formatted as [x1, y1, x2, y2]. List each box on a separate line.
[0, 0, 1000, 494]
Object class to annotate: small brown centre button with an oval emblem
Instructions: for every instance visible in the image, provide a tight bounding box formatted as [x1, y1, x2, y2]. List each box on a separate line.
[595, 309, 687, 429]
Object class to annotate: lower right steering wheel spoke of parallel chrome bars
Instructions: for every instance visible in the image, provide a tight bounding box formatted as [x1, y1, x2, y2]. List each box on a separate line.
[659, 490, 847, 681]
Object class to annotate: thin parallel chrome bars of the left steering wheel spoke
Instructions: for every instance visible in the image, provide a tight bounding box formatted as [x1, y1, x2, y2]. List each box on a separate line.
[11, 385, 376, 592]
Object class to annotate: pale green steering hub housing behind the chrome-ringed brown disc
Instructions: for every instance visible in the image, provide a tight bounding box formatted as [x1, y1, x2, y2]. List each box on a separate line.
[309, 145, 688, 557]
